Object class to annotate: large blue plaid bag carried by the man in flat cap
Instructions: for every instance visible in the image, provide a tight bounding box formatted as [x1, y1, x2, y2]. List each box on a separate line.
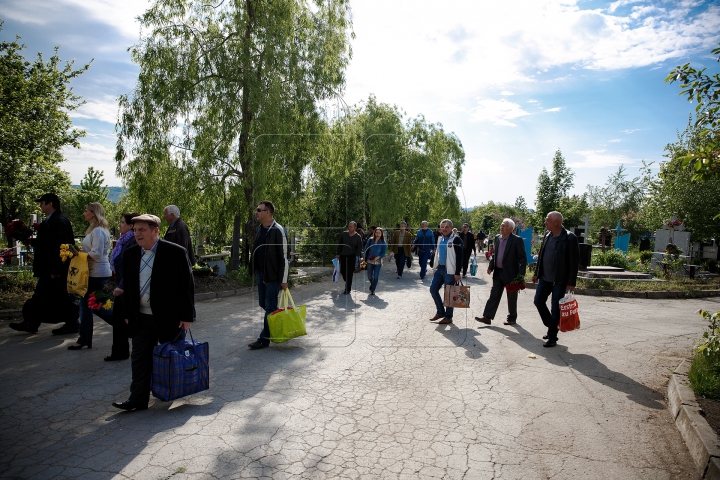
[151, 330, 210, 402]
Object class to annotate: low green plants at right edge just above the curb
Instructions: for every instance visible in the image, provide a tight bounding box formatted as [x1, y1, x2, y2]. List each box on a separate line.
[688, 310, 720, 398]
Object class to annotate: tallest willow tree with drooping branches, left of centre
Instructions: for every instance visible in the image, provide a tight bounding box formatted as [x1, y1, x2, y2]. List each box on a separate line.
[116, 0, 352, 259]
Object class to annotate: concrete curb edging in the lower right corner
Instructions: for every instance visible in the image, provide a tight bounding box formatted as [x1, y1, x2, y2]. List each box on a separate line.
[668, 360, 720, 480]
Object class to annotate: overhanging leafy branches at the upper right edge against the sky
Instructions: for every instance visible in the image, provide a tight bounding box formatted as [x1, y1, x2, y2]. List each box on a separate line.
[665, 42, 720, 180]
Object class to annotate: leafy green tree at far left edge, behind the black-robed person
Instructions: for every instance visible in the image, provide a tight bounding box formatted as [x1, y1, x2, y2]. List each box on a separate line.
[0, 22, 90, 231]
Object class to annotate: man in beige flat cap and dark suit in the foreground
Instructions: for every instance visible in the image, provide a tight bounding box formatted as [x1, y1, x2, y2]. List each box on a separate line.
[113, 214, 195, 410]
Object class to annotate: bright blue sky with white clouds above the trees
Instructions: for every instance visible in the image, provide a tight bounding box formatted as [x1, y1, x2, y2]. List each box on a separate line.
[0, 0, 720, 207]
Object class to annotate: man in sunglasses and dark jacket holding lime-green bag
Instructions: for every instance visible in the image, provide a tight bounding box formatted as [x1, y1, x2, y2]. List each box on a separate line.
[248, 200, 290, 350]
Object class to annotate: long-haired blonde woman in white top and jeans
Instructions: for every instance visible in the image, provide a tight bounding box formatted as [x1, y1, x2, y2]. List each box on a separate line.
[68, 202, 112, 350]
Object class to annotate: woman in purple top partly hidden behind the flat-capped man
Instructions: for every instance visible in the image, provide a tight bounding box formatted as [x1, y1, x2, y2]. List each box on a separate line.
[105, 212, 140, 362]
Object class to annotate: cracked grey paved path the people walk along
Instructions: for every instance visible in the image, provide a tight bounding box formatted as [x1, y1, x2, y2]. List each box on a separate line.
[0, 258, 720, 480]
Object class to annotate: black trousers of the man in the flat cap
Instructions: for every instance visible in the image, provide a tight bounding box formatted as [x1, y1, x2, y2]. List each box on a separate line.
[130, 313, 180, 404]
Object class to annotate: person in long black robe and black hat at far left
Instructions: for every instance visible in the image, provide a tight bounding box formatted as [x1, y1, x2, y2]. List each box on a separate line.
[10, 193, 80, 335]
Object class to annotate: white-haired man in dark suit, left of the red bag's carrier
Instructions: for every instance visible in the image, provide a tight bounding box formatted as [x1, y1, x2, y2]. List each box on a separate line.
[475, 218, 527, 325]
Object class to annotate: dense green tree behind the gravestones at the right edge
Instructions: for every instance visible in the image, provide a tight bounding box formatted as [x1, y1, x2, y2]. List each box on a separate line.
[643, 120, 720, 242]
